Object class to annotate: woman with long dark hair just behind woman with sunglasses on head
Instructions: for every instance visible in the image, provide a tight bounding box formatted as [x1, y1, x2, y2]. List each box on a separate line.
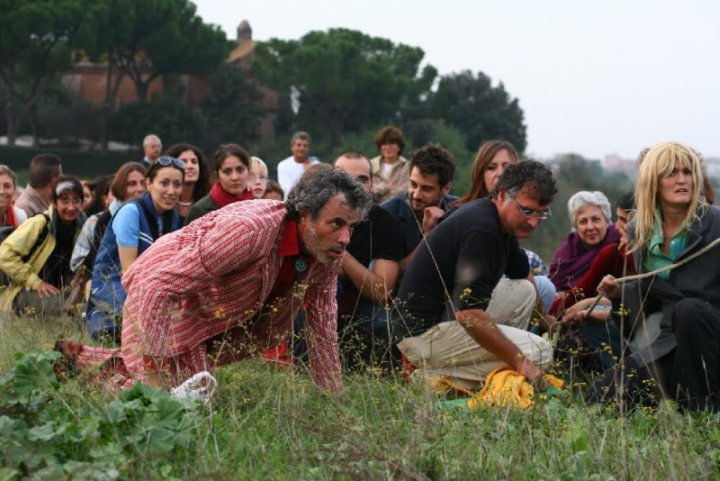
[165, 144, 210, 219]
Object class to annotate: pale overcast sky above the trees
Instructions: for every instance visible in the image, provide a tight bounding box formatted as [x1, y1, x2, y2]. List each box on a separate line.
[194, 0, 720, 158]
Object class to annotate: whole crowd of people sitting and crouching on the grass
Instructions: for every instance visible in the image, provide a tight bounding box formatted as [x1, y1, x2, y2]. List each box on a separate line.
[0, 126, 720, 410]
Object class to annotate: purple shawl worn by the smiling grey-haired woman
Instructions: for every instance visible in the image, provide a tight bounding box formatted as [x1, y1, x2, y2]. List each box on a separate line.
[550, 224, 620, 291]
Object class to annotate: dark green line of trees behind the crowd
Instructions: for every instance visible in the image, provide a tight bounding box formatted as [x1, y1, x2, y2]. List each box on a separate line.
[0, 0, 526, 171]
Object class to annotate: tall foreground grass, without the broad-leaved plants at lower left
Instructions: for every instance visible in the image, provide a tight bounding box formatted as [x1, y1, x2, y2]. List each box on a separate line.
[0, 318, 720, 480]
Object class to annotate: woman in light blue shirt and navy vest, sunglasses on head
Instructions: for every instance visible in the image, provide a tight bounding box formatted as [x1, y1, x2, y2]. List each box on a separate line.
[86, 157, 185, 339]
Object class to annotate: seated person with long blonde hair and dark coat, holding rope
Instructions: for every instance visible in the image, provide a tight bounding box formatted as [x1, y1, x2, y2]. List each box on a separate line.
[600, 142, 720, 411]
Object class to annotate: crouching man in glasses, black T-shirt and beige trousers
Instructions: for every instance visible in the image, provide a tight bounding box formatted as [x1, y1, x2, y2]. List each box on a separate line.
[393, 161, 557, 389]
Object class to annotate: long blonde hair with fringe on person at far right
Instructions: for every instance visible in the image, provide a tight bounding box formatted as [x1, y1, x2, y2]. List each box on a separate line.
[630, 142, 707, 252]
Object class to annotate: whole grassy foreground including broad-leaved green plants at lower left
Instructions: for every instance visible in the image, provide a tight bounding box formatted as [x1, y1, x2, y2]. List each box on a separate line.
[0, 319, 720, 480]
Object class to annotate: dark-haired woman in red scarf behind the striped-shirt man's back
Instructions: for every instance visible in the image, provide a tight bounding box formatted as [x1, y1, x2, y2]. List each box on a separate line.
[185, 144, 255, 225]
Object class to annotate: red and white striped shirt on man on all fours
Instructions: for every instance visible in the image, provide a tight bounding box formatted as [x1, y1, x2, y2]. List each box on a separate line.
[114, 200, 342, 391]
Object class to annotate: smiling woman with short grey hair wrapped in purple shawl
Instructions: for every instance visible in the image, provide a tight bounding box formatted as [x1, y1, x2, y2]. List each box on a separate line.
[550, 190, 620, 291]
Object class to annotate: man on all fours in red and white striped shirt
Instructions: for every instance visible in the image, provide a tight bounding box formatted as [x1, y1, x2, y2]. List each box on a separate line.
[57, 169, 371, 391]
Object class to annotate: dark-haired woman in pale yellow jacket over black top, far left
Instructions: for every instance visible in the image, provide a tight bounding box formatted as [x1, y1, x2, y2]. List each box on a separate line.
[0, 177, 85, 316]
